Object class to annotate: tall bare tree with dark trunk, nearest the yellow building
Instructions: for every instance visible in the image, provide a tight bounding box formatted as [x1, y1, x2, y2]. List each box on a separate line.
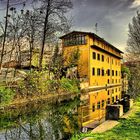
[34, 0, 72, 70]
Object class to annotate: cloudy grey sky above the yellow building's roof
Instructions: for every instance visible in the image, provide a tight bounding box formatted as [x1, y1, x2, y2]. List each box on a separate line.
[0, 0, 140, 51]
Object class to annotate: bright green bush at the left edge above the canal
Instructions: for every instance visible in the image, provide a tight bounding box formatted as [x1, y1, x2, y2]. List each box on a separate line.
[0, 87, 15, 105]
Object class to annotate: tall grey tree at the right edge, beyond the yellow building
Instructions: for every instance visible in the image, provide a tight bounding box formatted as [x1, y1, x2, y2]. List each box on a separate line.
[126, 12, 140, 98]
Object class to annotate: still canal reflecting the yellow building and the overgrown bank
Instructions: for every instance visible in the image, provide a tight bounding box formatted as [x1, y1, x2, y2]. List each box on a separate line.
[0, 86, 122, 140]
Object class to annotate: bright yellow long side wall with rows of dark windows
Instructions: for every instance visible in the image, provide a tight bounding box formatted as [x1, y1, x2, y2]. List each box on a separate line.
[90, 36, 121, 86]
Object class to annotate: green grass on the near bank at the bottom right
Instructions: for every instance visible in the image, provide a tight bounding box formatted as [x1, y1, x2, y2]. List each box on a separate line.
[71, 98, 140, 140]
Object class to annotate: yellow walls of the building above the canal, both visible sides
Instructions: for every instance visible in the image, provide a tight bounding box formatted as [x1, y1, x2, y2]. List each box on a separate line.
[63, 35, 121, 86]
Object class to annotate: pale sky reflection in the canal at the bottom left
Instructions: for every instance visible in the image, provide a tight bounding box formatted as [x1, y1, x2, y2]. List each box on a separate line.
[0, 121, 62, 140]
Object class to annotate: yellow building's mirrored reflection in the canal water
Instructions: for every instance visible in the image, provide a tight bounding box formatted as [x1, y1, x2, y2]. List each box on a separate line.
[82, 86, 122, 126]
